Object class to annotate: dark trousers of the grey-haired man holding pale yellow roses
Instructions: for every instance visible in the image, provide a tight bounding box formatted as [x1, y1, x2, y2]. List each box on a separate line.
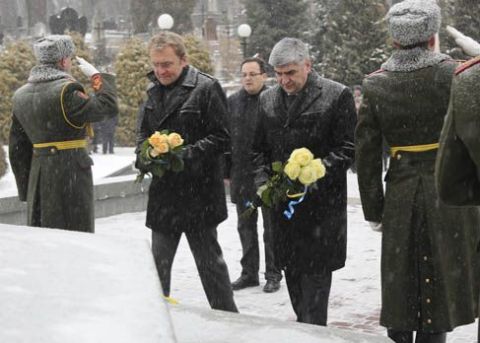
[285, 267, 332, 326]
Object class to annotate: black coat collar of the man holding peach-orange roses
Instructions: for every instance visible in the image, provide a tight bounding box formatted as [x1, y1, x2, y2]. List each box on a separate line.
[147, 66, 198, 126]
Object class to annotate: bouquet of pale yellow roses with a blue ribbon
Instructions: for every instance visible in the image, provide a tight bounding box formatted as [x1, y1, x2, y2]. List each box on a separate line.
[242, 148, 325, 219]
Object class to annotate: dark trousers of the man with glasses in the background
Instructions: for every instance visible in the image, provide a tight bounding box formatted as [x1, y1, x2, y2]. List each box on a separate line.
[236, 204, 282, 281]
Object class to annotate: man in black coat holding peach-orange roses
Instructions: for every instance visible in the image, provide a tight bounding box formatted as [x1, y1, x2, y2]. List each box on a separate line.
[137, 32, 237, 312]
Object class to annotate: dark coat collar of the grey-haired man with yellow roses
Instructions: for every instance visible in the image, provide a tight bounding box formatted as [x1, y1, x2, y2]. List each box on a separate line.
[275, 70, 322, 127]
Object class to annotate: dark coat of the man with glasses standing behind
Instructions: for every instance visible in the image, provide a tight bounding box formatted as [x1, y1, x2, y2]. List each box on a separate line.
[227, 88, 266, 203]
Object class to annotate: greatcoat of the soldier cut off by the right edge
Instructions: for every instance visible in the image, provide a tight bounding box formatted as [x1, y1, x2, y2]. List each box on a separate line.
[436, 56, 480, 206]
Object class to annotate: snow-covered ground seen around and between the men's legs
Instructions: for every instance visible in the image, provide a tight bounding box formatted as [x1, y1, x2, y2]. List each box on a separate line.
[0, 148, 477, 343]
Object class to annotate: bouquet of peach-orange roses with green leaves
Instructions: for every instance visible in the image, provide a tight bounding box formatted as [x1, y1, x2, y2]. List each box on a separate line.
[135, 130, 185, 182]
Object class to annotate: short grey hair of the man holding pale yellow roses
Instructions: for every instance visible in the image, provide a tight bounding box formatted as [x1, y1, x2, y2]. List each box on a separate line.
[268, 37, 310, 67]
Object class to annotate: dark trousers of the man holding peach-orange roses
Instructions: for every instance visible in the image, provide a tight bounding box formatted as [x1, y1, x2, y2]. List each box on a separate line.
[152, 226, 238, 312]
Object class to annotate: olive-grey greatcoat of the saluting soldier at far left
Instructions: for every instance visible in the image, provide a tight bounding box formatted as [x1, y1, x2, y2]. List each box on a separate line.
[9, 74, 118, 232]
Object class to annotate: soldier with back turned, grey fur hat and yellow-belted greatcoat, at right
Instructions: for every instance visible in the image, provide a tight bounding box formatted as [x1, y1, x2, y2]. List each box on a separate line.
[356, 0, 479, 343]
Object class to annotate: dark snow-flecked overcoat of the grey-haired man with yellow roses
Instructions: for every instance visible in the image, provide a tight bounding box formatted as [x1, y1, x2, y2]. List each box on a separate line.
[253, 72, 356, 274]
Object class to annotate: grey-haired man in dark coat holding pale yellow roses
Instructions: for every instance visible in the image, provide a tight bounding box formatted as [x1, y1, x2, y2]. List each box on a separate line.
[253, 38, 356, 325]
